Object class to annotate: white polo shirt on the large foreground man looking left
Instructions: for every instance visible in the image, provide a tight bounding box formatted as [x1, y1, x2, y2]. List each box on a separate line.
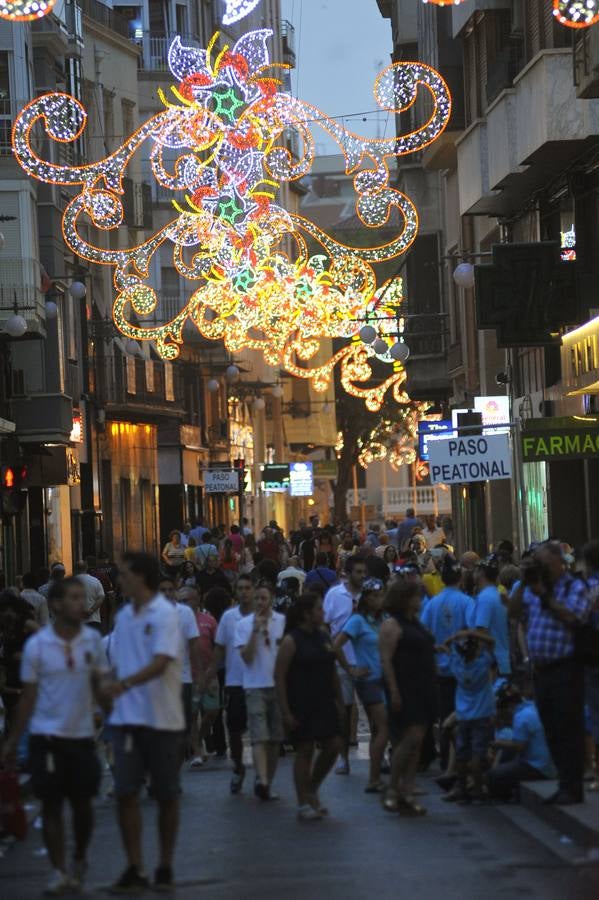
[110, 594, 185, 731]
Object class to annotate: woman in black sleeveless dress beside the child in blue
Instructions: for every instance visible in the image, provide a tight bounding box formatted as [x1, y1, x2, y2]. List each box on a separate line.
[379, 581, 437, 815]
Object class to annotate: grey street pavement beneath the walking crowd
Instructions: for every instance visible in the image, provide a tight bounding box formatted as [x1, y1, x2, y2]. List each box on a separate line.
[0, 746, 599, 900]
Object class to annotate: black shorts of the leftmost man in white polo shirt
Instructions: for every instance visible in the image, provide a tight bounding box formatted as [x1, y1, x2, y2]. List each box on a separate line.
[29, 734, 102, 802]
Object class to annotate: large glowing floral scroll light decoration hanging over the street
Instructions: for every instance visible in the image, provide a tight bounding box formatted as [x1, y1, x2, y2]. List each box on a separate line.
[13, 29, 451, 411]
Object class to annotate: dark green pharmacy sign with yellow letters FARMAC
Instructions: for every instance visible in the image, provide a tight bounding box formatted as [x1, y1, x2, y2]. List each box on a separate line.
[522, 416, 599, 462]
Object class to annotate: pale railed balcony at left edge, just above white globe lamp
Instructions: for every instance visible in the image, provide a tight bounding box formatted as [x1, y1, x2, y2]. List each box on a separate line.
[0, 256, 46, 337]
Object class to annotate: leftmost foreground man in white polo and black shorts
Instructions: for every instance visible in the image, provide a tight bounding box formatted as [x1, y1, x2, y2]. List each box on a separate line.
[4, 578, 105, 896]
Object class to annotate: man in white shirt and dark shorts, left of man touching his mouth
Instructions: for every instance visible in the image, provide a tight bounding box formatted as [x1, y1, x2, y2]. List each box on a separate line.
[206, 575, 254, 794]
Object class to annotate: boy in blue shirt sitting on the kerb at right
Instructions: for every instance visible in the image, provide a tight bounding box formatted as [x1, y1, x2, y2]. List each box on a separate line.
[486, 684, 556, 801]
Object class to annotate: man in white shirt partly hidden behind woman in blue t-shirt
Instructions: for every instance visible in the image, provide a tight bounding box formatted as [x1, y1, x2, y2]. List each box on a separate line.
[324, 556, 368, 775]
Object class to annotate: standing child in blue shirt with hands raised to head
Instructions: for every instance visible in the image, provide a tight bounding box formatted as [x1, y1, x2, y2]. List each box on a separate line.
[440, 630, 496, 803]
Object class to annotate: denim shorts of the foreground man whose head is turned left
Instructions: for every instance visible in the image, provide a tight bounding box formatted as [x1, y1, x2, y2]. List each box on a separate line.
[112, 725, 184, 801]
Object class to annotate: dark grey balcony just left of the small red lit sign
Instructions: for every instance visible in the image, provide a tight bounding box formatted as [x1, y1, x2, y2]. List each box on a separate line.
[12, 394, 73, 445]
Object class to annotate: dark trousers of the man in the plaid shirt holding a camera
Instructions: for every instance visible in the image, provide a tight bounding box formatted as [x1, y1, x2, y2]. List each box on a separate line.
[534, 658, 585, 797]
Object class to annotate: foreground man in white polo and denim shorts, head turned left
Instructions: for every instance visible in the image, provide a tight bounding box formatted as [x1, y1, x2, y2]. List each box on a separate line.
[110, 553, 185, 894]
